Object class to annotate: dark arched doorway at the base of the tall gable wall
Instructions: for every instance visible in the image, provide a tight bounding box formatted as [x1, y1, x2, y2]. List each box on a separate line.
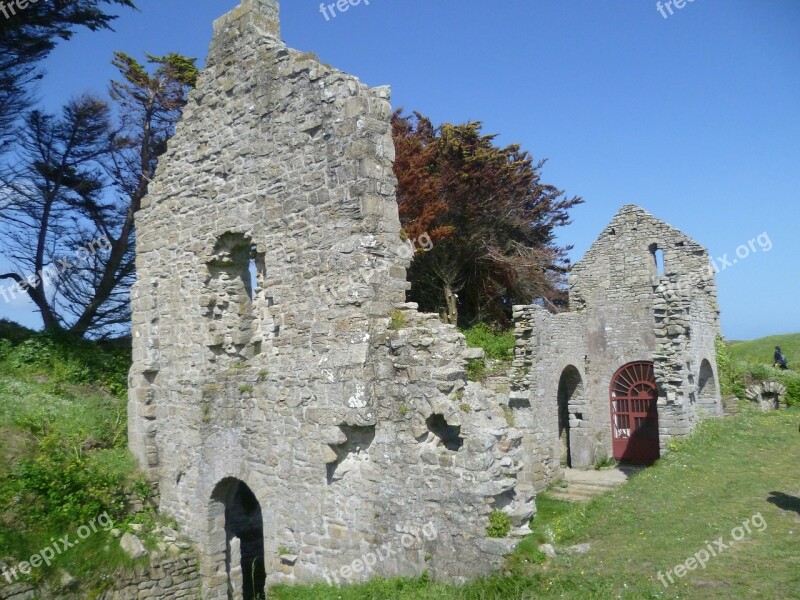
[211, 477, 266, 600]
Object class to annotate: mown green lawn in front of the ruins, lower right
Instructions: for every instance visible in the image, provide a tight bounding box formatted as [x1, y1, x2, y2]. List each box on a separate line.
[271, 409, 800, 600]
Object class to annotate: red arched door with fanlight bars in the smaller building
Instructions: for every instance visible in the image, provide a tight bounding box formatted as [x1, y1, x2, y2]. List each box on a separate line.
[610, 361, 659, 464]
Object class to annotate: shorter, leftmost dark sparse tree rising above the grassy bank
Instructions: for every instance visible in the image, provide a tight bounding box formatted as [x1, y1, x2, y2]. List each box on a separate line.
[0, 96, 119, 329]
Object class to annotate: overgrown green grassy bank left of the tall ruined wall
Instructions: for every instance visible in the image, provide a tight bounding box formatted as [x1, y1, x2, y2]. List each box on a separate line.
[0, 323, 152, 597]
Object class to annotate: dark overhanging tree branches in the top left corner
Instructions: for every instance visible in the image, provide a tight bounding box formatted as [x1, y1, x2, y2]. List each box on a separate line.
[0, 0, 135, 145]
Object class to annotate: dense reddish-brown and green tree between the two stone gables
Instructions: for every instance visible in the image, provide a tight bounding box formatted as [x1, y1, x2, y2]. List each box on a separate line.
[393, 112, 582, 326]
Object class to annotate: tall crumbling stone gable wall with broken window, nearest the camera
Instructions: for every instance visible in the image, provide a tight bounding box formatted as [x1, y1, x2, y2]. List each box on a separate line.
[129, 0, 533, 598]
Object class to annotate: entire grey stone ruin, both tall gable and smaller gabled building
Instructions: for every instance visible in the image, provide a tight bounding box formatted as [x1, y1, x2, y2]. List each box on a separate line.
[129, 0, 720, 598]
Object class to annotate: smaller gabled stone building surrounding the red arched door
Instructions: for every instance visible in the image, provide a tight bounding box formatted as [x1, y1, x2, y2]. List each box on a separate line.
[512, 205, 721, 490]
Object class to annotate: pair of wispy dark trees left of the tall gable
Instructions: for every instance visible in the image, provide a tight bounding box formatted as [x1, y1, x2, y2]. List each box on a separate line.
[0, 53, 197, 336]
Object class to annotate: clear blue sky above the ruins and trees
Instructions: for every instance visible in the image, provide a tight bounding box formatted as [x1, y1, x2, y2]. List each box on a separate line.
[0, 0, 800, 339]
